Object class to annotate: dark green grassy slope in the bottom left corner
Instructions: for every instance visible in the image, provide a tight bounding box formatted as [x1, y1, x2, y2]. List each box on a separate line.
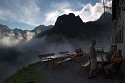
[3, 63, 45, 83]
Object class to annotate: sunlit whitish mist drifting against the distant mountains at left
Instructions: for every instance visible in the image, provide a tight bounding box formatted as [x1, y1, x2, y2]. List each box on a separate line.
[0, 31, 36, 47]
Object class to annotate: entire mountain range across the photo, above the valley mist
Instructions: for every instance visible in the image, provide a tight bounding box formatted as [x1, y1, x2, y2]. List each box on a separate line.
[0, 13, 114, 46]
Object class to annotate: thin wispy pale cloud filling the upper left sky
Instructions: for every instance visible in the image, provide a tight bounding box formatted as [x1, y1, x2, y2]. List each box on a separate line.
[0, 0, 42, 26]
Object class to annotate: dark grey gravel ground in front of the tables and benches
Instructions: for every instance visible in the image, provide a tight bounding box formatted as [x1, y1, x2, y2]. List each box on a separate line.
[37, 63, 115, 83]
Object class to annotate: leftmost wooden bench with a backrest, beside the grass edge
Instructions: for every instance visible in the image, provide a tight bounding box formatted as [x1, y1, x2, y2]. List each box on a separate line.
[38, 53, 55, 67]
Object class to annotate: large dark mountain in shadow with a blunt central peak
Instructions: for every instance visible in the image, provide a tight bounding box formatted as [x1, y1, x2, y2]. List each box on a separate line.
[36, 13, 114, 41]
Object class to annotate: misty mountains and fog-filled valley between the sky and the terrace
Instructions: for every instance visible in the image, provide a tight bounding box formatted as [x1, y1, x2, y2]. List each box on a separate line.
[0, 13, 114, 80]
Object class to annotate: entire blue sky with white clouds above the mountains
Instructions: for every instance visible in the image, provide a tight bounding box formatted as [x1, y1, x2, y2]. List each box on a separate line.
[0, 0, 112, 30]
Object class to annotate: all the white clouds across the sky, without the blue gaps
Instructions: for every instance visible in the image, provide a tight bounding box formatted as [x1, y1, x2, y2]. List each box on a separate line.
[0, 0, 112, 26]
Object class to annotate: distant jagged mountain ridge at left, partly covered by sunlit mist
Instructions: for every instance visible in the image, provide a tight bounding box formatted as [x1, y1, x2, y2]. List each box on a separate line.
[0, 24, 52, 41]
